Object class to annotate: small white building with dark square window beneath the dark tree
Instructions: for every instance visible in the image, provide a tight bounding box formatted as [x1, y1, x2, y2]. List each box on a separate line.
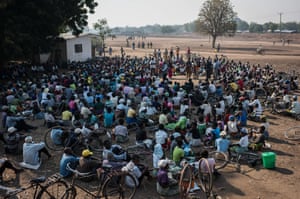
[41, 33, 101, 64]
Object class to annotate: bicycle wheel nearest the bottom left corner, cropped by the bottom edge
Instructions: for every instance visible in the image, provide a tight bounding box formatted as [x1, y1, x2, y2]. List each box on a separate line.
[37, 180, 69, 199]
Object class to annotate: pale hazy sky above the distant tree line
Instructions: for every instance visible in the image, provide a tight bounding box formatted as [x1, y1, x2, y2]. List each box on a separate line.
[89, 0, 300, 28]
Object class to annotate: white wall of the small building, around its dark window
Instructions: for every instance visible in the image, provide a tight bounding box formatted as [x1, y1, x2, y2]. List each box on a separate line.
[66, 35, 92, 62]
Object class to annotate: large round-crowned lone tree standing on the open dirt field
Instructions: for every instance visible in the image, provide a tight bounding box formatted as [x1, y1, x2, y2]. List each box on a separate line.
[198, 0, 236, 48]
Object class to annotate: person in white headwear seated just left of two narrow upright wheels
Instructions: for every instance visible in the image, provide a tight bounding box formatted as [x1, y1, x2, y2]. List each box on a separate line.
[156, 160, 179, 196]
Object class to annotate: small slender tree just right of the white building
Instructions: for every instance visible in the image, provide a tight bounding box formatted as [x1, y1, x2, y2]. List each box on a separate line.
[94, 19, 116, 57]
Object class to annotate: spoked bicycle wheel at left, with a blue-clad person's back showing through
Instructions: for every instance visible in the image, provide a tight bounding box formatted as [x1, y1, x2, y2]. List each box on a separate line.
[44, 126, 68, 151]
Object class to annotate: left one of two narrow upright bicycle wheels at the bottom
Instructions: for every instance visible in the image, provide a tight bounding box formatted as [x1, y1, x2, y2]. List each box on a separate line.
[179, 164, 194, 198]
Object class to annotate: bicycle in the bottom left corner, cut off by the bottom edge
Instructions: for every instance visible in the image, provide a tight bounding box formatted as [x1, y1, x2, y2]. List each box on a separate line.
[4, 174, 68, 199]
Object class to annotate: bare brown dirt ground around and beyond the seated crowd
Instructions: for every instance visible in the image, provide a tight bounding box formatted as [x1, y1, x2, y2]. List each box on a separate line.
[0, 34, 300, 199]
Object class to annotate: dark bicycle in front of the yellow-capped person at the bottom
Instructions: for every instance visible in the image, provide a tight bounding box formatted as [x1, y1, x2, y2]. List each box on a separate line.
[41, 164, 136, 199]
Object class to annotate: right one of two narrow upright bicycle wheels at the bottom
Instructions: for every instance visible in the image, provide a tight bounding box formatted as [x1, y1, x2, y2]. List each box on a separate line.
[198, 158, 213, 196]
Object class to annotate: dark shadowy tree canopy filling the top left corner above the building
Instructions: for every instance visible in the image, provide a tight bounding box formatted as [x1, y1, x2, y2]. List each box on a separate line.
[0, 0, 97, 64]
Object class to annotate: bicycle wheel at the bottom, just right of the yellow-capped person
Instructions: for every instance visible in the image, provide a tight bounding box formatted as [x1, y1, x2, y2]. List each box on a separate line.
[102, 172, 137, 199]
